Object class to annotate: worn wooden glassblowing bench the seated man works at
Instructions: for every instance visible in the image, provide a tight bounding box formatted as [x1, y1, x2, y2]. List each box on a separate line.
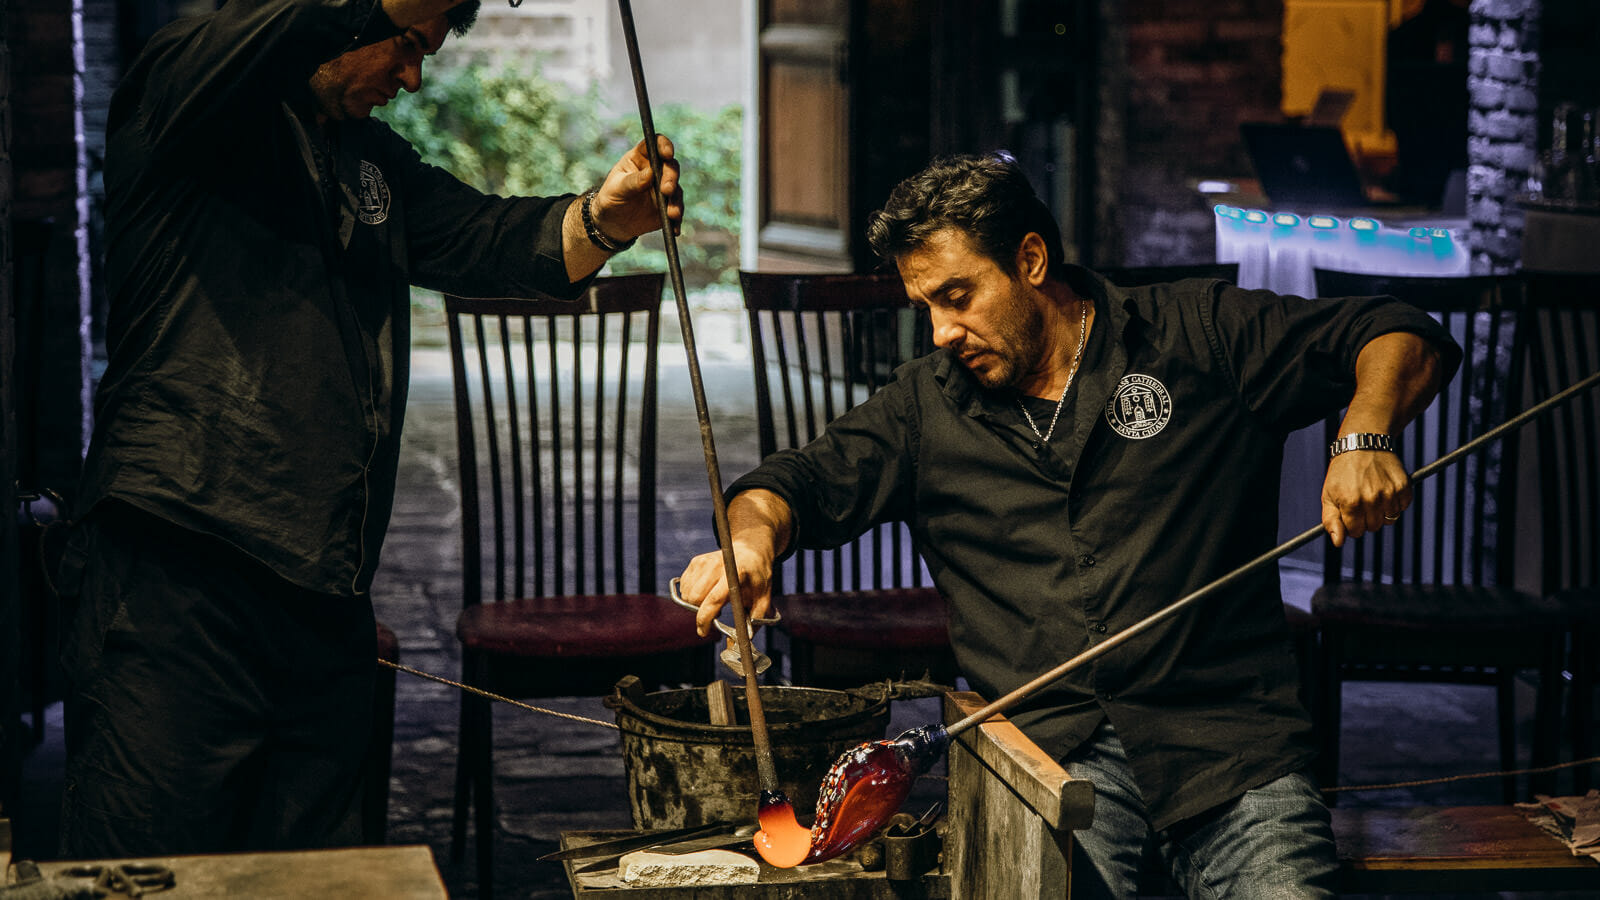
[563, 692, 1600, 900]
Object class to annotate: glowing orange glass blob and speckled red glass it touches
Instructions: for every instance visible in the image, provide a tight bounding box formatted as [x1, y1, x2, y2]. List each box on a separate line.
[755, 725, 950, 868]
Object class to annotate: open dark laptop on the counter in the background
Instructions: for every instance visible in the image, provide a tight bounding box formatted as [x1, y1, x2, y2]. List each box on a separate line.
[1238, 122, 1389, 213]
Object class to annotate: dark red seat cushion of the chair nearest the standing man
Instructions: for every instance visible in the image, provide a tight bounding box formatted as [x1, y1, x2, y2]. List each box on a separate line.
[456, 594, 717, 658]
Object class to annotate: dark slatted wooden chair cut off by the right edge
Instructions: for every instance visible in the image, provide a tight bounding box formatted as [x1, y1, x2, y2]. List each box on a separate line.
[1517, 272, 1600, 794]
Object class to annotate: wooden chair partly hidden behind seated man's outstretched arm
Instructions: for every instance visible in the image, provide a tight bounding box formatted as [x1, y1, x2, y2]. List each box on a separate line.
[739, 272, 955, 687]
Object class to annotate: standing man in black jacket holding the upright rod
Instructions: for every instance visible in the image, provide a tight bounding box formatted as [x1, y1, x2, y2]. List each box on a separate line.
[61, 0, 683, 857]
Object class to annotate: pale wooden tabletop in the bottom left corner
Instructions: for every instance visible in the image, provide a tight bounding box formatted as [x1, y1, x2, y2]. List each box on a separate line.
[26, 846, 450, 900]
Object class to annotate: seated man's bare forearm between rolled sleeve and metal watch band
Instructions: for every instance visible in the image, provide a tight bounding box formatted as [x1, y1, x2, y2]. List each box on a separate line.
[1339, 331, 1442, 436]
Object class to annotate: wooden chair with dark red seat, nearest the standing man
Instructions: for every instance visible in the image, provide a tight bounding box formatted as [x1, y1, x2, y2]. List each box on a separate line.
[445, 274, 715, 897]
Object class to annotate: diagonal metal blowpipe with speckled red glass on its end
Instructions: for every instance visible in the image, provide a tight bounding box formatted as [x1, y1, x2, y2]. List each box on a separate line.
[780, 365, 1600, 865]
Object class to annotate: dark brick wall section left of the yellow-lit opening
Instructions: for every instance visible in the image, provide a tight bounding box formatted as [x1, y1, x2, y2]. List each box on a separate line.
[1096, 0, 1283, 266]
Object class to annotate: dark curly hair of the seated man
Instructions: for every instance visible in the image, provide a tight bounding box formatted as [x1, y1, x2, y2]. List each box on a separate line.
[867, 151, 1064, 279]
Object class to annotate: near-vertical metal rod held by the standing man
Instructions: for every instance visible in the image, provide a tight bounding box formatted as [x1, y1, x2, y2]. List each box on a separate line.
[618, 0, 779, 791]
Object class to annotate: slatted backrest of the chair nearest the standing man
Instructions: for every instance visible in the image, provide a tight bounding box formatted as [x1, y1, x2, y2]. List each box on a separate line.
[445, 274, 664, 604]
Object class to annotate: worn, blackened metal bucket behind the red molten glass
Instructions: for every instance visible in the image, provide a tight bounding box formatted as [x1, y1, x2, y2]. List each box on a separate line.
[605, 679, 890, 830]
